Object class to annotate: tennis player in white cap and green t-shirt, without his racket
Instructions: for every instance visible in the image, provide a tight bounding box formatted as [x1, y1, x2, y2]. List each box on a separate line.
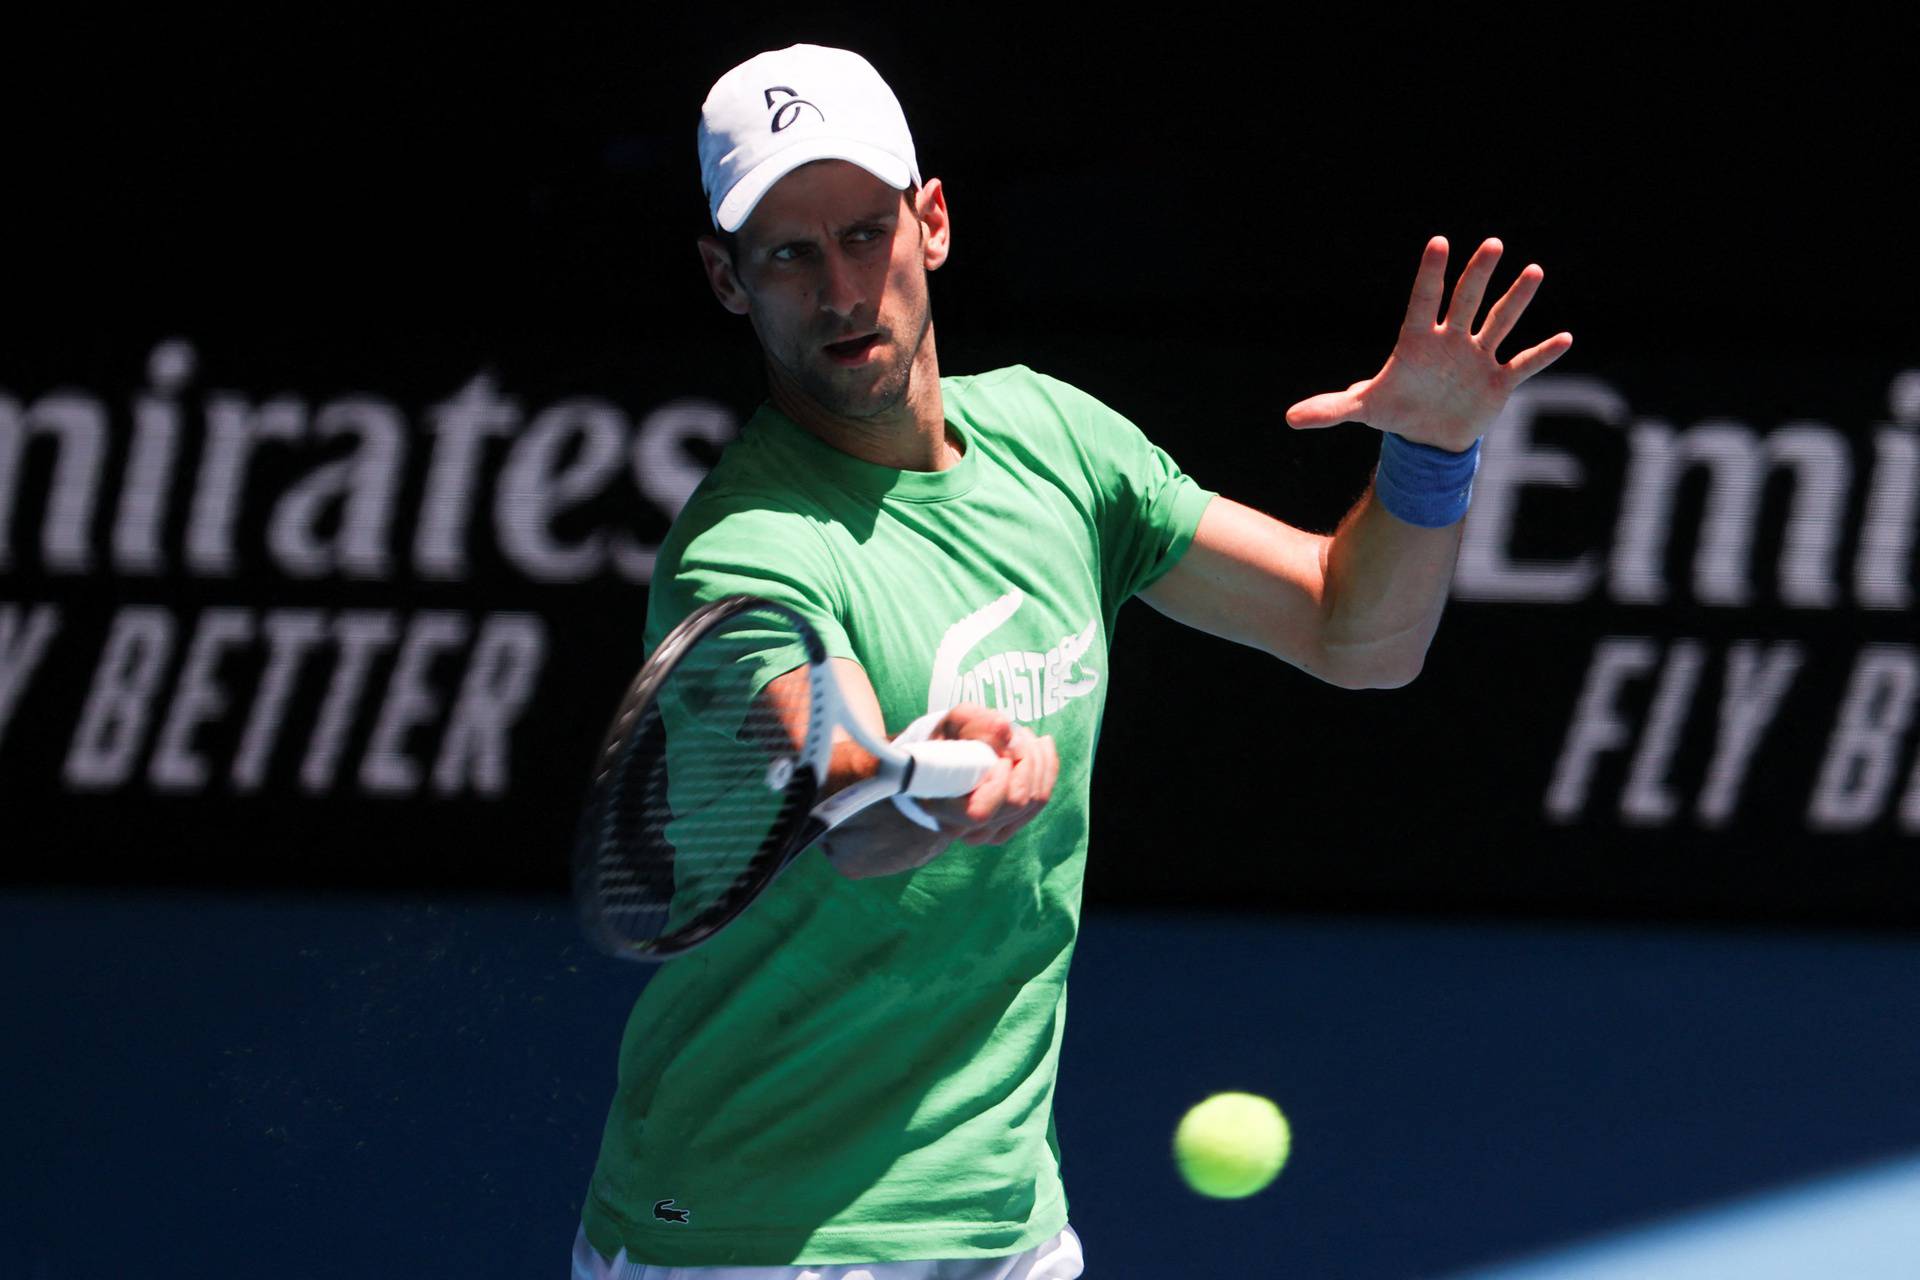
[574, 44, 1572, 1280]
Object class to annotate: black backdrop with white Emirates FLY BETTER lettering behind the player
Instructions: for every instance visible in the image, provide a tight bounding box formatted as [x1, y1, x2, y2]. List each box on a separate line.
[0, 6, 1920, 925]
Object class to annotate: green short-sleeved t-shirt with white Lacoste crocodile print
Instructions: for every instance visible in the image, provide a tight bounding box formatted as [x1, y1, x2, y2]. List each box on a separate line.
[584, 367, 1210, 1267]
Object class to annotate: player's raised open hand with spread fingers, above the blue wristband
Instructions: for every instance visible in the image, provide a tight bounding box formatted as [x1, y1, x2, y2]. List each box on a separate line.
[1286, 236, 1572, 453]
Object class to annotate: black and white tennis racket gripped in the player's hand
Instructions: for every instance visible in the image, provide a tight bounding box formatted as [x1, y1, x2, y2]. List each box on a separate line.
[574, 595, 996, 961]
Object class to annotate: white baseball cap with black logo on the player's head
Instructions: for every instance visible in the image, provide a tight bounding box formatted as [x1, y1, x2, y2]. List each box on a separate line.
[699, 44, 920, 230]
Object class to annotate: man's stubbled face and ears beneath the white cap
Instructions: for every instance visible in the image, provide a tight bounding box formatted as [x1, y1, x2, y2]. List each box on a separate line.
[703, 159, 947, 418]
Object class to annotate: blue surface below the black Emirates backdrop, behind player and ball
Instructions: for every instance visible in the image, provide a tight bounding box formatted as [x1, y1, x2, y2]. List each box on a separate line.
[0, 892, 1920, 1280]
